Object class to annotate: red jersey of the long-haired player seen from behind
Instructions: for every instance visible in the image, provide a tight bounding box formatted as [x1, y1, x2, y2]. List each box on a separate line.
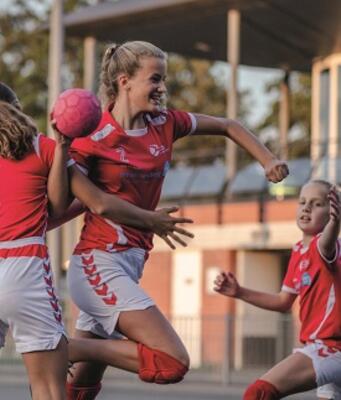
[0, 134, 55, 241]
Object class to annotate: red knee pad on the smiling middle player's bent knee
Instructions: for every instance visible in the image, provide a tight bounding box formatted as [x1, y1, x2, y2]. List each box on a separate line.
[138, 343, 189, 384]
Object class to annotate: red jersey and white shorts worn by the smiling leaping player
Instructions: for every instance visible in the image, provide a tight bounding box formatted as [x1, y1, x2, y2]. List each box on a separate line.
[68, 110, 196, 338]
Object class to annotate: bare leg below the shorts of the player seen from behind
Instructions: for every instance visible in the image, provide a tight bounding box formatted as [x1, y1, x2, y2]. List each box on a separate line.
[22, 337, 68, 400]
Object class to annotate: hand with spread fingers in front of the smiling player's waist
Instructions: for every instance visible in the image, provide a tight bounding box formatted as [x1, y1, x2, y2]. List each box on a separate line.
[151, 207, 194, 250]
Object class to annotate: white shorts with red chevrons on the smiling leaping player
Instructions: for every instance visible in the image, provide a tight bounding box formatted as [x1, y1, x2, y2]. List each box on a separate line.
[68, 248, 154, 338]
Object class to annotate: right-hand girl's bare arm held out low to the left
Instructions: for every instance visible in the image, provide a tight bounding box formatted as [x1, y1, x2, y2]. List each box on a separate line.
[214, 272, 296, 312]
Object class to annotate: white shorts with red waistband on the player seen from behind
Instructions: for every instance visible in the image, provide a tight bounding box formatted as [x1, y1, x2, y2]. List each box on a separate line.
[0, 241, 65, 353]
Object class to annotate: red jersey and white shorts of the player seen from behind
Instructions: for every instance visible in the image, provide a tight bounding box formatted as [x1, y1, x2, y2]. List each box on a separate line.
[0, 134, 65, 353]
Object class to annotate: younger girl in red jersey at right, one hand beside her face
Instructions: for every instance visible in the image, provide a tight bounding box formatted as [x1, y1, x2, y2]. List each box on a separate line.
[215, 180, 341, 400]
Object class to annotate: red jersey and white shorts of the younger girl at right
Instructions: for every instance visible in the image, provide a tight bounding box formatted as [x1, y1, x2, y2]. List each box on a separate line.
[282, 235, 341, 399]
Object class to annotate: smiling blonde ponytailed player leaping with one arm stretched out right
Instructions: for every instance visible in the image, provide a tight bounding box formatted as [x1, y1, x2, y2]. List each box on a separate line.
[68, 41, 288, 399]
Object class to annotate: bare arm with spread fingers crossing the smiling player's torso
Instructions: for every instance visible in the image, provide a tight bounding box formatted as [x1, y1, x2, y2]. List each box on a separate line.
[69, 165, 193, 249]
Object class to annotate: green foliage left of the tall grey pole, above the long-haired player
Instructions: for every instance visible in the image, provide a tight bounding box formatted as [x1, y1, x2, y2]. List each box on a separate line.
[0, 0, 48, 128]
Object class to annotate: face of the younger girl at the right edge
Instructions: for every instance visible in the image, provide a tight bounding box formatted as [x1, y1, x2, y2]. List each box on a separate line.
[296, 182, 329, 236]
